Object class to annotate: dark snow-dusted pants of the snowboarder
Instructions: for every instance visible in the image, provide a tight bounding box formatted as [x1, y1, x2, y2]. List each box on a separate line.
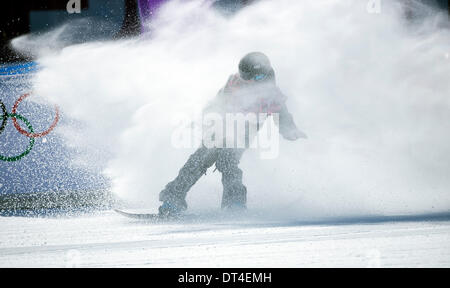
[159, 146, 247, 209]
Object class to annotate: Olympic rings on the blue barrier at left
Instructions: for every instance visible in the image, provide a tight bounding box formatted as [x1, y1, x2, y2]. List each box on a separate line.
[0, 93, 59, 162]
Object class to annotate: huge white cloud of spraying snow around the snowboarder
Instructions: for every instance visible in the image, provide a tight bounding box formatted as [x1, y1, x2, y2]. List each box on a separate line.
[18, 0, 450, 218]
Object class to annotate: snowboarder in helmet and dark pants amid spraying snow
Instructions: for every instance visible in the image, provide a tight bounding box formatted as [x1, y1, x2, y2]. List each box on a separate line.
[159, 52, 306, 217]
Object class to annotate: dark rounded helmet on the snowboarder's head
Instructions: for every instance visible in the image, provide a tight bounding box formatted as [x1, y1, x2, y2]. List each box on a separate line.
[239, 52, 275, 81]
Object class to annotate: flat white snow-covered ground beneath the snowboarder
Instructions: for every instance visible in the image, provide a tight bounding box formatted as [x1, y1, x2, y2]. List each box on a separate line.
[0, 211, 450, 267]
